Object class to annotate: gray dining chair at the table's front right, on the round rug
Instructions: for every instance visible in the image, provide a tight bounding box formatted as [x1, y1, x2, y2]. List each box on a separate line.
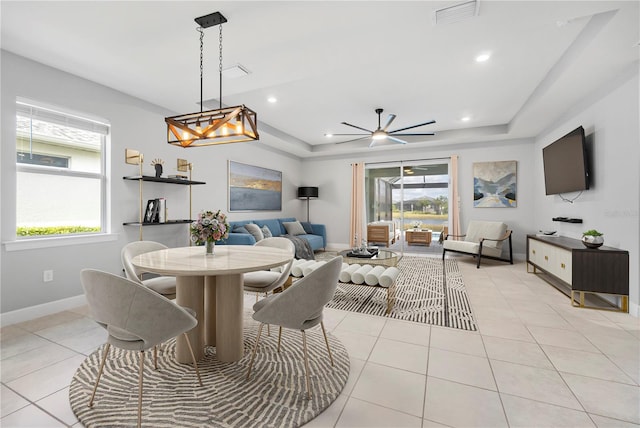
[247, 257, 342, 398]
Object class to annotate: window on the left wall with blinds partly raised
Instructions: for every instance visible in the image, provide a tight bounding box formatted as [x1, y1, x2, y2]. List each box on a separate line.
[16, 101, 109, 238]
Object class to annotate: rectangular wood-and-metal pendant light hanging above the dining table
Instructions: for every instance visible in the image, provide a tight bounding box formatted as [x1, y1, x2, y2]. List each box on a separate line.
[164, 12, 260, 147]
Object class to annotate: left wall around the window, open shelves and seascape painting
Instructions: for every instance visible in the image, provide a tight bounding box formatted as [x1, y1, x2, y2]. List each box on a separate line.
[0, 51, 306, 315]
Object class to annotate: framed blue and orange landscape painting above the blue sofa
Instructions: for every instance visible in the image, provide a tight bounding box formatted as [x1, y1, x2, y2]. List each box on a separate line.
[229, 160, 282, 212]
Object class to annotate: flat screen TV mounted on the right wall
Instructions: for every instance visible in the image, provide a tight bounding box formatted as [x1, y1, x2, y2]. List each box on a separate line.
[542, 126, 589, 195]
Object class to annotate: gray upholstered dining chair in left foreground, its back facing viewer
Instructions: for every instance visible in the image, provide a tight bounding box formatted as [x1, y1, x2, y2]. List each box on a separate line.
[80, 269, 202, 427]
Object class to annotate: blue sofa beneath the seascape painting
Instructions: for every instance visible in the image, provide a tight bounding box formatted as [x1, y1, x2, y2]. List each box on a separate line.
[217, 217, 327, 251]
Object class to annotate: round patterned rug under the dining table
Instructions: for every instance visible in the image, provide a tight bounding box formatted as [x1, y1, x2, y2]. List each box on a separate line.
[69, 314, 349, 427]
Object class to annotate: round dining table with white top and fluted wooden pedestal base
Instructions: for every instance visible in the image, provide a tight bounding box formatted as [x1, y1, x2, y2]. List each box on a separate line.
[132, 245, 291, 363]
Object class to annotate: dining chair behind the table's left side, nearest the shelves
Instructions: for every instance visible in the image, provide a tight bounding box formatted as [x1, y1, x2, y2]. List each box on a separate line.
[120, 241, 176, 299]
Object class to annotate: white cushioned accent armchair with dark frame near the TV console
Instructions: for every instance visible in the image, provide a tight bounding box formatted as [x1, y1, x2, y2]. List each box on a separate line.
[442, 220, 513, 269]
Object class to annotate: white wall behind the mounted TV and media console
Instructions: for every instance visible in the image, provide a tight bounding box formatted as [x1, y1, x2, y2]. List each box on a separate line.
[534, 69, 640, 317]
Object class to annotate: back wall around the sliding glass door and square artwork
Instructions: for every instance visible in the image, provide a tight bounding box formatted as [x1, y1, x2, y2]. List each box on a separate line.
[301, 140, 538, 258]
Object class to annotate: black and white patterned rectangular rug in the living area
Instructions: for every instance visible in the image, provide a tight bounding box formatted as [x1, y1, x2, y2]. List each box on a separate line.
[327, 256, 477, 331]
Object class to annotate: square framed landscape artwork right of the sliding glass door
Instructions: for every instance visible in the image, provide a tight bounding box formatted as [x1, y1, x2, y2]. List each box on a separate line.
[473, 161, 517, 208]
